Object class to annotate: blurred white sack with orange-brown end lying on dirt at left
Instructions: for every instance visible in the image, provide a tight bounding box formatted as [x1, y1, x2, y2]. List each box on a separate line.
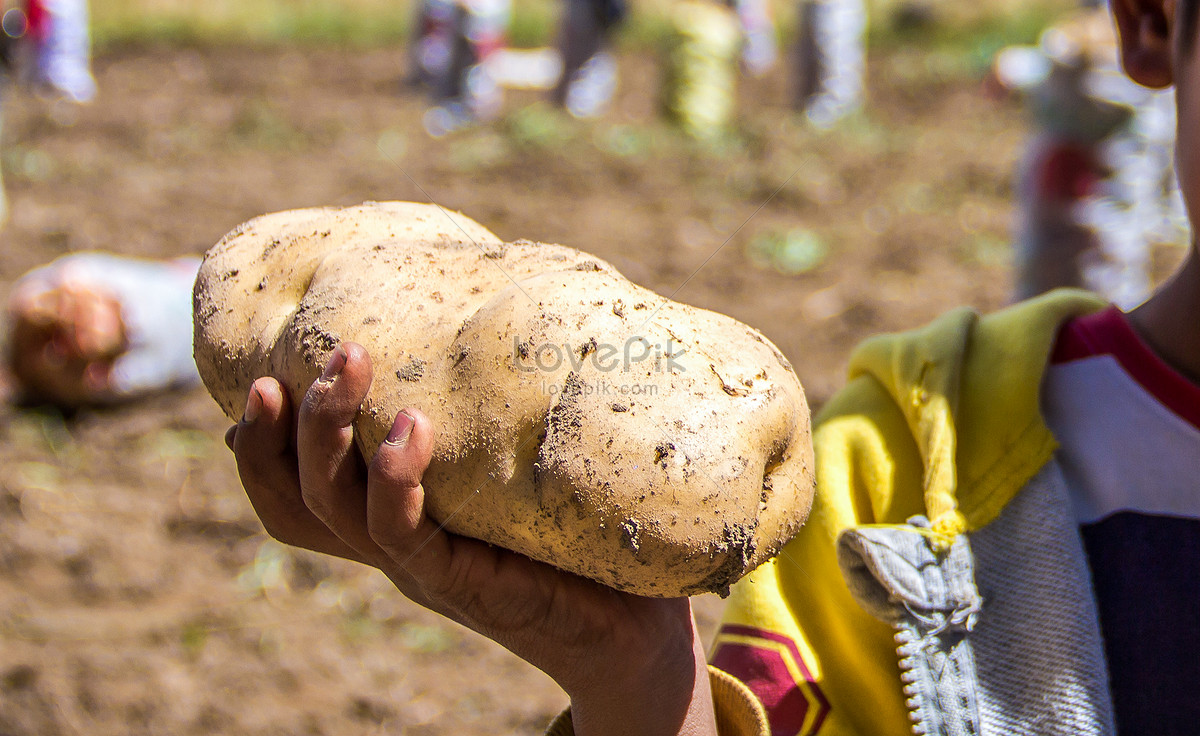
[6, 252, 199, 408]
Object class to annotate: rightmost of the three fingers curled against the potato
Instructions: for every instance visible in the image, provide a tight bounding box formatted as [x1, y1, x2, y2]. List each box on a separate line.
[367, 408, 462, 594]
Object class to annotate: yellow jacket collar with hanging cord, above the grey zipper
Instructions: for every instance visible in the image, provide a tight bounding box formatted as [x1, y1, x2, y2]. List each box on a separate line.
[850, 289, 1106, 535]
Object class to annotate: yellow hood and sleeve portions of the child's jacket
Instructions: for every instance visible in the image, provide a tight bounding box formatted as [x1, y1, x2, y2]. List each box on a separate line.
[712, 291, 1104, 736]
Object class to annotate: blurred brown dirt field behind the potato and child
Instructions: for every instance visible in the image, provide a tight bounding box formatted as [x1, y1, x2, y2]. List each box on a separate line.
[0, 42, 1180, 736]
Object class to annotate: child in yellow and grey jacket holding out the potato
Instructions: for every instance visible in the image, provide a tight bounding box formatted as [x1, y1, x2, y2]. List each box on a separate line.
[228, 0, 1200, 736]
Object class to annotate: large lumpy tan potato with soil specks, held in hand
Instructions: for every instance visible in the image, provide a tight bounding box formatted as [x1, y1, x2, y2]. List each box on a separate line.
[196, 203, 812, 597]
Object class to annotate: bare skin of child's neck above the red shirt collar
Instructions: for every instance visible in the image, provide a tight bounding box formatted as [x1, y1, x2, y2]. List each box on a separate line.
[1129, 244, 1200, 384]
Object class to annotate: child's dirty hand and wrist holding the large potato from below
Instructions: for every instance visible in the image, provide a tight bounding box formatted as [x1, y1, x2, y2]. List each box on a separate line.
[227, 343, 715, 735]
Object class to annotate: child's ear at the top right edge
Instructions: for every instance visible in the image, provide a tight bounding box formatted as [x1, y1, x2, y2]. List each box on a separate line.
[1110, 0, 1175, 89]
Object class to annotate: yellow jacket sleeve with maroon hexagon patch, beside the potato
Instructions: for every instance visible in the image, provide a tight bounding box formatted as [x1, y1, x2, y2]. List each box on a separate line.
[709, 376, 924, 736]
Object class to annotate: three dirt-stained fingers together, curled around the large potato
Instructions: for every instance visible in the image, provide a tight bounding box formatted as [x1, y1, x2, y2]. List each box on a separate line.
[226, 342, 446, 578]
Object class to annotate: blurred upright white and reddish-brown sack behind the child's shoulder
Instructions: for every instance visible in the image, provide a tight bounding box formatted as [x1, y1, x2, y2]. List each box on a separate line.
[995, 7, 1187, 303]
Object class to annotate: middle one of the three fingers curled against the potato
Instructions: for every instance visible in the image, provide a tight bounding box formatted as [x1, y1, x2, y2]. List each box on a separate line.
[296, 342, 382, 564]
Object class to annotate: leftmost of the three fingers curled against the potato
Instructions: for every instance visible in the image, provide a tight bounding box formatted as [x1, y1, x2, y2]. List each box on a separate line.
[226, 378, 364, 562]
